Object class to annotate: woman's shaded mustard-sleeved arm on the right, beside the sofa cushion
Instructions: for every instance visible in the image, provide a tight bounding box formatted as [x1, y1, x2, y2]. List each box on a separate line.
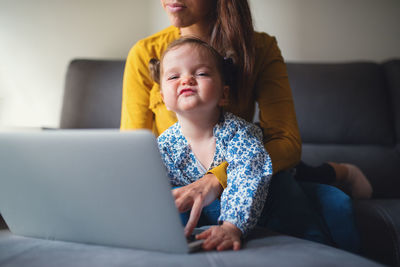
[255, 33, 301, 173]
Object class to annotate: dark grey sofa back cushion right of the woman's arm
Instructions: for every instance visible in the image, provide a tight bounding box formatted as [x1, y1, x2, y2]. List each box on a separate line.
[288, 63, 394, 145]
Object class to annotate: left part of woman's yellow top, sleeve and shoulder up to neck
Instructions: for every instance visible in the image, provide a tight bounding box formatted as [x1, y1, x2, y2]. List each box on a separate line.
[121, 26, 180, 135]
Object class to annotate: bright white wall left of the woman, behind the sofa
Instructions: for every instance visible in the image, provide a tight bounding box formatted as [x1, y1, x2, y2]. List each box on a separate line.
[0, 0, 149, 127]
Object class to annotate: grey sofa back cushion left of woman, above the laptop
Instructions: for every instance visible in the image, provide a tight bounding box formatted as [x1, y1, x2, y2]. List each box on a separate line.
[60, 59, 125, 129]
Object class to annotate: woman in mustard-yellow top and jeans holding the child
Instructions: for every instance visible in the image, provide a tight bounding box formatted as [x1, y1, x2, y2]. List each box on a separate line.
[121, 0, 368, 253]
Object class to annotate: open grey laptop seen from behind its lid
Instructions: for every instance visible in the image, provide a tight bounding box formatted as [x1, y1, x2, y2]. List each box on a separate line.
[0, 130, 205, 253]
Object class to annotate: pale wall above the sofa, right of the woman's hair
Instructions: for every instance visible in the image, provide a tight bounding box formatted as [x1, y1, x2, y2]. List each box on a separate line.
[250, 0, 400, 61]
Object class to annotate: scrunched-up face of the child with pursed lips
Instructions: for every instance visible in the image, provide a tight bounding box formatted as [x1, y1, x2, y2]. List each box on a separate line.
[161, 44, 227, 114]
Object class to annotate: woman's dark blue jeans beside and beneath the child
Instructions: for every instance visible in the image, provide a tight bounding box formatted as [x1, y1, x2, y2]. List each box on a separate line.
[181, 172, 359, 252]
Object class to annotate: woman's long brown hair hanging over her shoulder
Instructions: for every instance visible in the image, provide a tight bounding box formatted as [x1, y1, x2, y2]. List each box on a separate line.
[210, 0, 255, 108]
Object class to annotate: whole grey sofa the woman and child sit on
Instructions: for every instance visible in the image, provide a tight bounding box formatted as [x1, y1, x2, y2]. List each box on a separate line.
[0, 60, 400, 266]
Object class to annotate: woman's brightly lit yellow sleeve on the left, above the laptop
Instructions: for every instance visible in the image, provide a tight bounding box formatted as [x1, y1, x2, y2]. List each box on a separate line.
[121, 41, 153, 130]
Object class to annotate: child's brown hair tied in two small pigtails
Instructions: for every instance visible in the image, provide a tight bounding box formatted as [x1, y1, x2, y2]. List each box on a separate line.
[149, 37, 235, 87]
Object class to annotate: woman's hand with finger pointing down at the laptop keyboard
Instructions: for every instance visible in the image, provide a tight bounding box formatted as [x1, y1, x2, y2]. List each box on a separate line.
[172, 173, 223, 236]
